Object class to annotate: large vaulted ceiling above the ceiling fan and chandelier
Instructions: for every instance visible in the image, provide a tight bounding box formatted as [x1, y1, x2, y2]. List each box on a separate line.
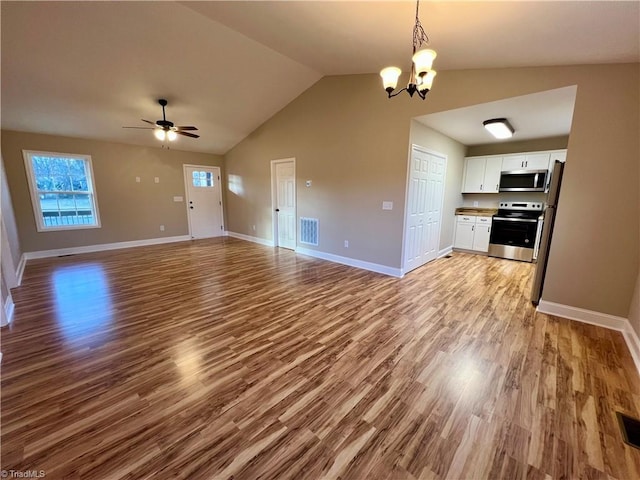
[1, 1, 640, 153]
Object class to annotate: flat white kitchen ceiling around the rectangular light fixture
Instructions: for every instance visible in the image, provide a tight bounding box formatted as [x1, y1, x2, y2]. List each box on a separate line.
[416, 86, 577, 145]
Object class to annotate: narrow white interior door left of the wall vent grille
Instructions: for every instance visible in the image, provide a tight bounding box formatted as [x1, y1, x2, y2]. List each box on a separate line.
[272, 159, 296, 250]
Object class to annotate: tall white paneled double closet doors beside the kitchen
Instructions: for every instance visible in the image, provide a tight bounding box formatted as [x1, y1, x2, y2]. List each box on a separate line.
[404, 145, 447, 272]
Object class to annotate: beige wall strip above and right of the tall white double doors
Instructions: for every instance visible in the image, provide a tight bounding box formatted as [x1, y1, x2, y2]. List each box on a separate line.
[409, 120, 467, 250]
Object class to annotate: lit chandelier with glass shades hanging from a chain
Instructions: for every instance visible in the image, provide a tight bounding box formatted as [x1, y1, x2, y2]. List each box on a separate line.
[380, 0, 437, 100]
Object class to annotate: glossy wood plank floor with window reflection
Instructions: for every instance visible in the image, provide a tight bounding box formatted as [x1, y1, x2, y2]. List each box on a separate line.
[1, 238, 640, 480]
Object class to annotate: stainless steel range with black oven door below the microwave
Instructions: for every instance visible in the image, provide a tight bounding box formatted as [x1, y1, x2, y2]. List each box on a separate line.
[489, 202, 543, 262]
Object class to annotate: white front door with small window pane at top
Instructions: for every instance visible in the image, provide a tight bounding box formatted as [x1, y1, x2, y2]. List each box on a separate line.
[184, 165, 224, 238]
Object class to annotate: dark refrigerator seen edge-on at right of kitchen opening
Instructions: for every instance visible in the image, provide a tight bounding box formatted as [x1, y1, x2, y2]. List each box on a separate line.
[531, 160, 564, 305]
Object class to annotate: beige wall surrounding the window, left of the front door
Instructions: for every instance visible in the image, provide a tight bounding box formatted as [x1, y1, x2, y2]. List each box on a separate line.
[2, 131, 224, 252]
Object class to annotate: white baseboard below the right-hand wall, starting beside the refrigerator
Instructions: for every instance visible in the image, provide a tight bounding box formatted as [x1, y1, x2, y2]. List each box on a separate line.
[537, 300, 640, 374]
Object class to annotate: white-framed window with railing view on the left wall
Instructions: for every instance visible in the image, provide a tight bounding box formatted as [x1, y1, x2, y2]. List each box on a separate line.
[22, 150, 100, 232]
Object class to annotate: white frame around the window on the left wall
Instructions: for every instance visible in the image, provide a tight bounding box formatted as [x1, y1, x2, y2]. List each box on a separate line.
[22, 150, 102, 232]
